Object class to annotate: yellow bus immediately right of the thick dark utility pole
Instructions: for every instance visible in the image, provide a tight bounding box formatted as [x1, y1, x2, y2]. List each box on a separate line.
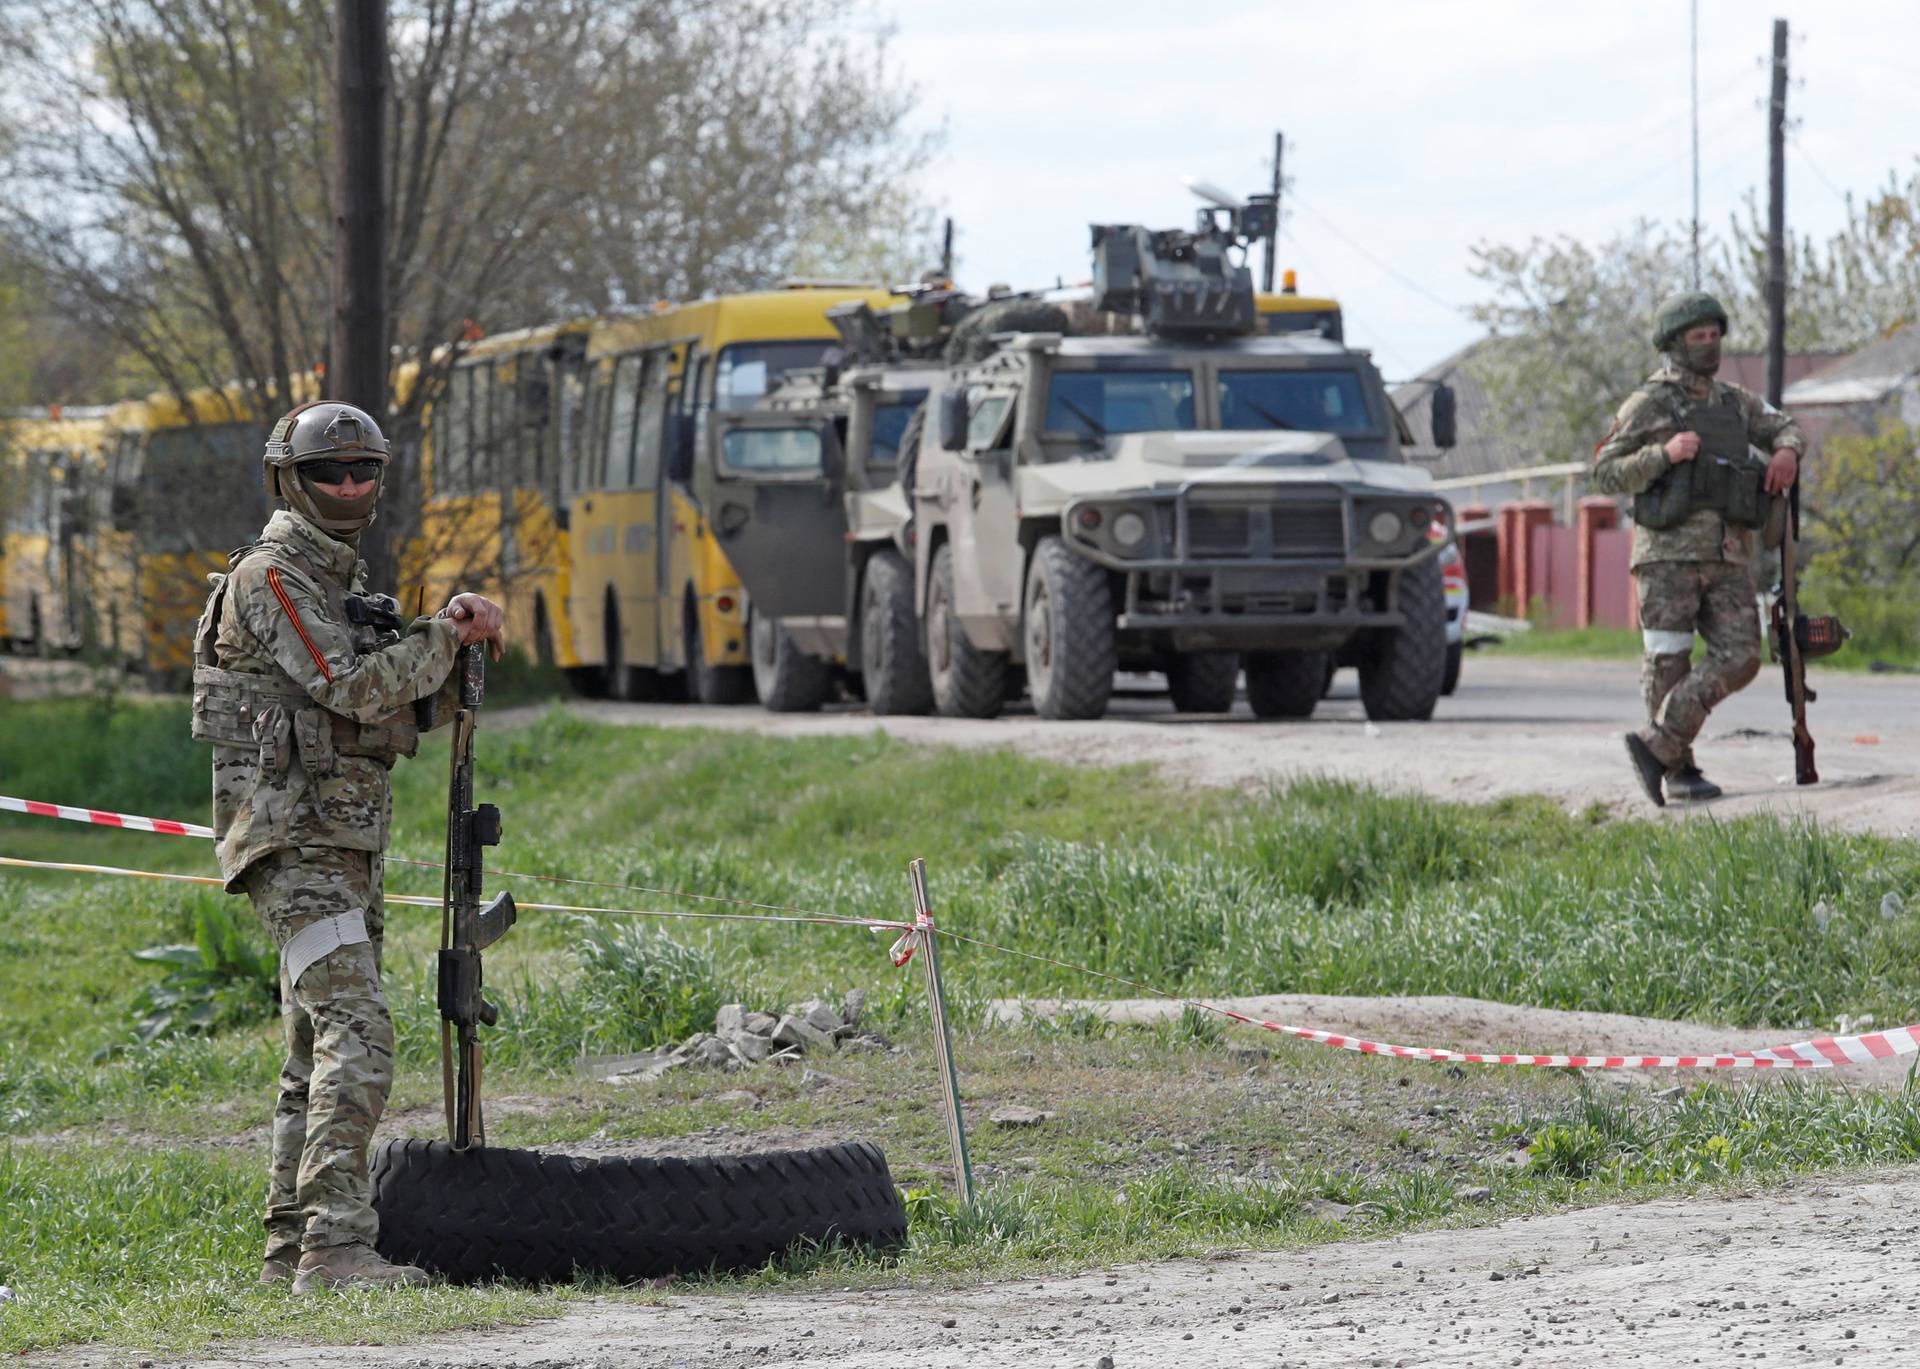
[414, 321, 593, 670]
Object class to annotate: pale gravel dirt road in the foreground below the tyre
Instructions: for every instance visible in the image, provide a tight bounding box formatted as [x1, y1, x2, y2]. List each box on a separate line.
[82, 1173, 1920, 1369]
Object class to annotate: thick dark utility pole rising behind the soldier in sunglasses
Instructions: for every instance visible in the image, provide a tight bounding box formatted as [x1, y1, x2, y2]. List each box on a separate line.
[326, 0, 396, 584]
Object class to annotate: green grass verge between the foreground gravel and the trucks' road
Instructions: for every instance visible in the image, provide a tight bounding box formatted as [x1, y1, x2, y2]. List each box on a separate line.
[0, 701, 1920, 1352]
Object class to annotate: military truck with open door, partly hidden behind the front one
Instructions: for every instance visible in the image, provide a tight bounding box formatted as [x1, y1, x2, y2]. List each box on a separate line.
[695, 284, 973, 712]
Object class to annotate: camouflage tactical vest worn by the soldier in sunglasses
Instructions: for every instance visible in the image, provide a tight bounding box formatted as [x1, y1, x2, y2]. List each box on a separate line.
[194, 547, 420, 780]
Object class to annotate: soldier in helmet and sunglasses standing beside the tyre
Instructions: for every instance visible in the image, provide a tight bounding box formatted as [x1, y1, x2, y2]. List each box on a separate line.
[194, 401, 501, 1292]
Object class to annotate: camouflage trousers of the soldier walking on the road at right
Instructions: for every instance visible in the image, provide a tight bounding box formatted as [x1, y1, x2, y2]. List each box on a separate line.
[1634, 561, 1761, 770]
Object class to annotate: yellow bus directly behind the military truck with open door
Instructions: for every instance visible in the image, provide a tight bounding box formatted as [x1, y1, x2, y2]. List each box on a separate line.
[561, 286, 893, 703]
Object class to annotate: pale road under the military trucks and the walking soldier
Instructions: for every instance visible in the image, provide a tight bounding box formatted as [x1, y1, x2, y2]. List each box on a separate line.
[574, 655, 1920, 835]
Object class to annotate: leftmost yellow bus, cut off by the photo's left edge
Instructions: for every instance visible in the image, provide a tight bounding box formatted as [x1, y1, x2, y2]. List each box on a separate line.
[0, 407, 108, 657]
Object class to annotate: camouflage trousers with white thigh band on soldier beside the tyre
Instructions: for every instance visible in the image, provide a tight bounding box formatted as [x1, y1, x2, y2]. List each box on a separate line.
[240, 847, 394, 1258]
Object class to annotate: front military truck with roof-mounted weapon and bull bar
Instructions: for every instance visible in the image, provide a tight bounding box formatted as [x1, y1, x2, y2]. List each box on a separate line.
[908, 205, 1452, 720]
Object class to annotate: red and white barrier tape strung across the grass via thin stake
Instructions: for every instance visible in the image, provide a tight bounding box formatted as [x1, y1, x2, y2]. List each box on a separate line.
[0, 795, 1920, 1069]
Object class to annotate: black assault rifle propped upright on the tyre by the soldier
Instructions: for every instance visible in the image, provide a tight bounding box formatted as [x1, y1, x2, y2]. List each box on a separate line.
[440, 641, 518, 1150]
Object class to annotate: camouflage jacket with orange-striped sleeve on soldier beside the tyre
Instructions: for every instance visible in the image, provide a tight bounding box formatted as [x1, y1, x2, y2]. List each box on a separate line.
[194, 509, 459, 889]
